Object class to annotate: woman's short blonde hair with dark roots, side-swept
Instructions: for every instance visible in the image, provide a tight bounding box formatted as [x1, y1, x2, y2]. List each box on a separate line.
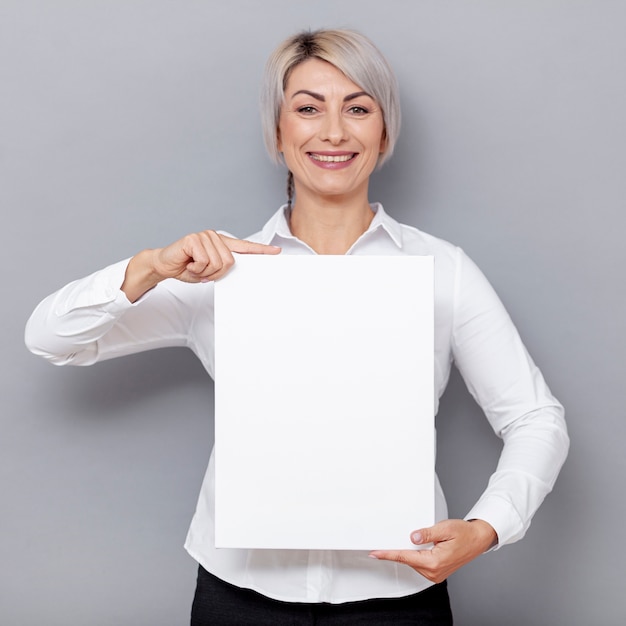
[261, 29, 400, 166]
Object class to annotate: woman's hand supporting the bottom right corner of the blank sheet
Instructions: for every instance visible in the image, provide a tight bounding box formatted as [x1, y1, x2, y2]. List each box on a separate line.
[370, 519, 498, 583]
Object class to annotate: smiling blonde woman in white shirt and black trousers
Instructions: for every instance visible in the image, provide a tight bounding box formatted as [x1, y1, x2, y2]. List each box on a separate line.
[26, 30, 568, 625]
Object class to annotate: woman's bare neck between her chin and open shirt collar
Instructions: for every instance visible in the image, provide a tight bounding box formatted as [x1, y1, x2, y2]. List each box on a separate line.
[289, 186, 374, 254]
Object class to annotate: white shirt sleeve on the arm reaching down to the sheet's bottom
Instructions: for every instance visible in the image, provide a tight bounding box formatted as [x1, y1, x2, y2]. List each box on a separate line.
[452, 246, 569, 547]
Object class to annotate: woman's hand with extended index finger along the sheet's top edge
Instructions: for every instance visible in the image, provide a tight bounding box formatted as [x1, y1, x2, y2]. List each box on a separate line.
[121, 230, 280, 302]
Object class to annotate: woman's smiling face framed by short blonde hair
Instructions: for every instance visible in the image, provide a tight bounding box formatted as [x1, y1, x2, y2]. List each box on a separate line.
[278, 59, 386, 200]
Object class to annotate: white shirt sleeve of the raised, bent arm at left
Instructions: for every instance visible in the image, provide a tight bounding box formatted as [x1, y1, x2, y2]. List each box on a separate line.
[25, 260, 199, 365]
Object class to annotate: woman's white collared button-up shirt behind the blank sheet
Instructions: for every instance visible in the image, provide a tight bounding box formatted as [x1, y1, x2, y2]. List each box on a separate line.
[26, 204, 569, 602]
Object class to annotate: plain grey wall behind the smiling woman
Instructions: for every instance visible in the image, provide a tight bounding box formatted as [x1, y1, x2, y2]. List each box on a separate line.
[0, 0, 626, 626]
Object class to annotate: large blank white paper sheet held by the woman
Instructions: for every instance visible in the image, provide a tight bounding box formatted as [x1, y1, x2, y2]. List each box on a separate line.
[215, 255, 435, 550]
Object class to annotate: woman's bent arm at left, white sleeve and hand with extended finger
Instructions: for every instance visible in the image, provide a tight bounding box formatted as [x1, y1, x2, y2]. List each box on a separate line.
[25, 231, 280, 365]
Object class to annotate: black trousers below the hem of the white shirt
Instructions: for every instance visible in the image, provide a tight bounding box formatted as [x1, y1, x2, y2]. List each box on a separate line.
[191, 566, 452, 626]
